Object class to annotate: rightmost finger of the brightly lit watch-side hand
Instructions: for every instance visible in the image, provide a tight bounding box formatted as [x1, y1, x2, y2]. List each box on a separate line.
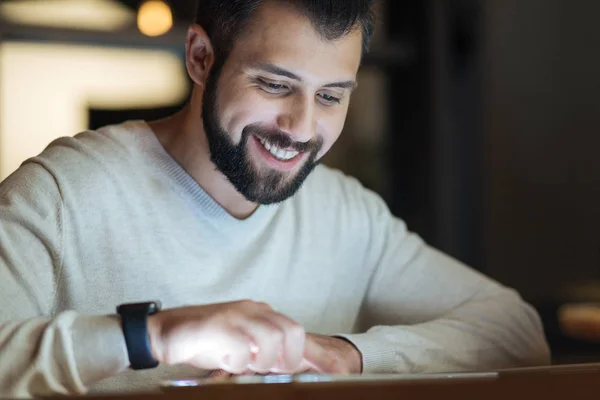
[265, 312, 306, 372]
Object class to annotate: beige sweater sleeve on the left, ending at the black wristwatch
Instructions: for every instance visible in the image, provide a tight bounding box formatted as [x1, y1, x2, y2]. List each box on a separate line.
[0, 162, 128, 398]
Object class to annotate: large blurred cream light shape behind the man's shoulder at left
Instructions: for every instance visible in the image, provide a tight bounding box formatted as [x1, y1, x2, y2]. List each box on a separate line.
[0, 42, 189, 180]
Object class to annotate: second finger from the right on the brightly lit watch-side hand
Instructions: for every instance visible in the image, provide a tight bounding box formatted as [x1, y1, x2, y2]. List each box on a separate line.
[240, 316, 284, 373]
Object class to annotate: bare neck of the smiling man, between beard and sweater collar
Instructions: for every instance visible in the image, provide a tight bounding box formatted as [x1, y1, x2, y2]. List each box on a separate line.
[150, 100, 258, 219]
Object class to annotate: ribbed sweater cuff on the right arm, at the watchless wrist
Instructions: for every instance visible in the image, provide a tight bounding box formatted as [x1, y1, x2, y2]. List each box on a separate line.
[334, 333, 400, 374]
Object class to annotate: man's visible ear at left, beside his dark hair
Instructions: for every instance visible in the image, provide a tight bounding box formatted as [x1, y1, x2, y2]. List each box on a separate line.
[185, 24, 215, 87]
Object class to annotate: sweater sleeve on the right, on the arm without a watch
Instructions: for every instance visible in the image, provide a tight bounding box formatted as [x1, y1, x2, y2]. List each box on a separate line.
[340, 177, 550, 373]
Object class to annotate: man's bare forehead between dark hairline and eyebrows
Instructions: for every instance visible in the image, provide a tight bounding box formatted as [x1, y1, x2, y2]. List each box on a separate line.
[225, 2, 362, 81]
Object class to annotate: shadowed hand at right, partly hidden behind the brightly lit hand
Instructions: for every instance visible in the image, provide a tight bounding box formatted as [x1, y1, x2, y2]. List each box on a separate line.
[210, 333, 362, 379]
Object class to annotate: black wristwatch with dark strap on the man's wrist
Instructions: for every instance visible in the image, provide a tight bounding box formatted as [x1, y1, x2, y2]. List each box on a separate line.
[117, 301, 161, 370]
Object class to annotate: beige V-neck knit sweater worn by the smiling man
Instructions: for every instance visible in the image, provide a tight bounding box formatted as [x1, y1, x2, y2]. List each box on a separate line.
[0, 121, 549, 397]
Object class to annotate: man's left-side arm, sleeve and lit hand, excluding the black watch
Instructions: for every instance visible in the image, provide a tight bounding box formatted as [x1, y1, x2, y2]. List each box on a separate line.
[0, 160, 314, 398]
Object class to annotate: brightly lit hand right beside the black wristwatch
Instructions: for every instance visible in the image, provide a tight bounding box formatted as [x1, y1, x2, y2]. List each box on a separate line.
[148, 300, 306, 374]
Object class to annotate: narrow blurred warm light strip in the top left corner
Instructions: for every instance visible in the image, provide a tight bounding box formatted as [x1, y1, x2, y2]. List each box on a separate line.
[0, 0, 135, 31]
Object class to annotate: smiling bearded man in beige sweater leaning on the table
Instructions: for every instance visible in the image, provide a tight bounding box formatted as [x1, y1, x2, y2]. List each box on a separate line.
[0, 0, 548, 397]
